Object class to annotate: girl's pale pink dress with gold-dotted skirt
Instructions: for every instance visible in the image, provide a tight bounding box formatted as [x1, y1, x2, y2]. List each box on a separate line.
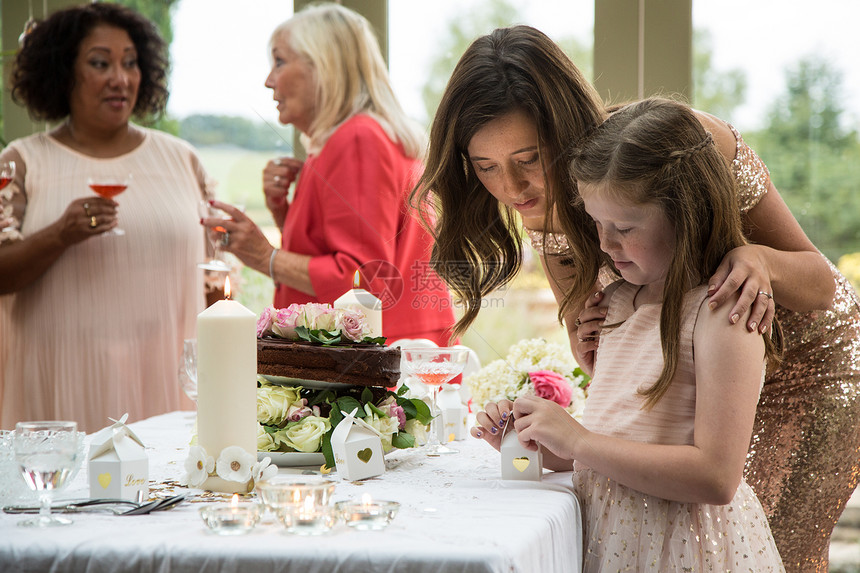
[573, 283, 784, 573]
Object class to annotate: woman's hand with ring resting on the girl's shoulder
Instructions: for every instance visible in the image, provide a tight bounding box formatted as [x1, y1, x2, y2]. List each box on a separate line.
[708, 245, 776, 334]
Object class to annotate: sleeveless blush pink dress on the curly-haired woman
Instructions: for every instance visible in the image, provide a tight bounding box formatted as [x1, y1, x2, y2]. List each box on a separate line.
[0, 130, 214, 432]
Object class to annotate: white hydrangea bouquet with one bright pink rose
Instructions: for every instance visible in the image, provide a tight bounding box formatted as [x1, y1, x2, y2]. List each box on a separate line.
[463, 338, 591, 417]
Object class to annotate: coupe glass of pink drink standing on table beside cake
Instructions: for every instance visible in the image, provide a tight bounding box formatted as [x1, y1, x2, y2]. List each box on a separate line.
[400, 347, 469, 456]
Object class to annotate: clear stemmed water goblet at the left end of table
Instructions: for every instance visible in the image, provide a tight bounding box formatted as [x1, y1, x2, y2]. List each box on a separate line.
[12, 422, 79, 527]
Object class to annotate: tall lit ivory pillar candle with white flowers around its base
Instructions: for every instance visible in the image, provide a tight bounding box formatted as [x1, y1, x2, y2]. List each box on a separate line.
[197, 278, 257, 493]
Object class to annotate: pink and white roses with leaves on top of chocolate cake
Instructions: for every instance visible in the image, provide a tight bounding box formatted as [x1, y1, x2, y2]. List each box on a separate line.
[257, 302, 385, 346]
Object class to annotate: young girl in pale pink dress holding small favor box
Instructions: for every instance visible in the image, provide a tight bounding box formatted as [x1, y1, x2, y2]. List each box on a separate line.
[472, 99, 784, 572]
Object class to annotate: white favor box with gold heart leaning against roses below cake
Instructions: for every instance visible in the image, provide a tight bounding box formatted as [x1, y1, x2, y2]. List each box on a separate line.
[331, 410, 385, 481]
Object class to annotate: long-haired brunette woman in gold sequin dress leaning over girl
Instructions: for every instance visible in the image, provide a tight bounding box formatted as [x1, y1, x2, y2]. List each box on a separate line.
[413, 26, 860, 571]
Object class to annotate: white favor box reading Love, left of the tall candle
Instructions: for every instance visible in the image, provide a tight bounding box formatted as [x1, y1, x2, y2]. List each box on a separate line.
[87, 414, 149, 502]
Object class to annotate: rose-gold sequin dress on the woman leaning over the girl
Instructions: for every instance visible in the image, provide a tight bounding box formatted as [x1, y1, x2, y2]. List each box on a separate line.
[732, 124, 860, 572]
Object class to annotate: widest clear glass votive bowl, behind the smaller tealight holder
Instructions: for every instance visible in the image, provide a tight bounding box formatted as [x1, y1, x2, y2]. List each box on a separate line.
[255, 474, 335, 520]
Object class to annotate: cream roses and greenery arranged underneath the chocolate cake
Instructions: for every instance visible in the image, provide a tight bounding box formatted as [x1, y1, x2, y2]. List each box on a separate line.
[257, 376, 431, 468]
